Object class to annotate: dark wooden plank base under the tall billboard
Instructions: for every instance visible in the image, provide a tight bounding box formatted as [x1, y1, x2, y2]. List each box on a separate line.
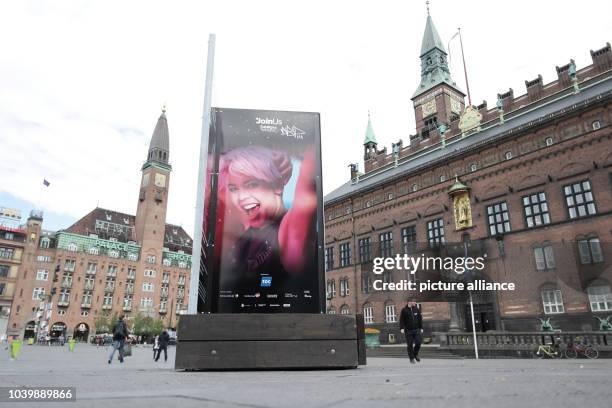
[175, 313, 366, 370]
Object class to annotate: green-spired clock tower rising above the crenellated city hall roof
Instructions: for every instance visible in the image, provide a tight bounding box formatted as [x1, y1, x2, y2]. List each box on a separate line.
[412, 10, 465, 140]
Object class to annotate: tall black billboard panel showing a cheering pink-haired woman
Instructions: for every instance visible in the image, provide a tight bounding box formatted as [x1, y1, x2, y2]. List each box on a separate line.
[199, 108, 325, 313]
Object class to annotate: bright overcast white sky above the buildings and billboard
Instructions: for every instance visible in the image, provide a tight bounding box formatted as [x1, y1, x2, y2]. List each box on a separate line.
[0, 0, 612, 234]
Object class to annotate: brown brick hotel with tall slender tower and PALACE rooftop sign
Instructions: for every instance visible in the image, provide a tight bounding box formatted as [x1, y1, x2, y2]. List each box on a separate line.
[1, 110, 192, 340]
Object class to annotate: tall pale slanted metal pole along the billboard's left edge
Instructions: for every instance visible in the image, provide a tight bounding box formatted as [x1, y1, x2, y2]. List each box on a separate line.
[187, 34, 216, 314]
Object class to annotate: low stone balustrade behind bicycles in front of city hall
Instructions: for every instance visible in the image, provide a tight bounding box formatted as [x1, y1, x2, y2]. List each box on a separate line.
[435, 331, 612, 349]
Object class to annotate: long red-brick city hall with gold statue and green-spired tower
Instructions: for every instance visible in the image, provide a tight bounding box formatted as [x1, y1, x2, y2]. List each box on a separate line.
[324, 16, 612, 342]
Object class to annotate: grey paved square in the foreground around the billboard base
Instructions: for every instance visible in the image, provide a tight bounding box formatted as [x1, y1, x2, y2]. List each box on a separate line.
[0, 344, 612, 408]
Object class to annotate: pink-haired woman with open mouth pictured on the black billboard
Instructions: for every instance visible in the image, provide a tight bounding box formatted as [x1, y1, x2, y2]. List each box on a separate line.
[217, 146, 317, 312]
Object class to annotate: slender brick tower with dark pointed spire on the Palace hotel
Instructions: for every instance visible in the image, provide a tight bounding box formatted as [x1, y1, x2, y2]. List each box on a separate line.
[135, 108, 172, 255]
